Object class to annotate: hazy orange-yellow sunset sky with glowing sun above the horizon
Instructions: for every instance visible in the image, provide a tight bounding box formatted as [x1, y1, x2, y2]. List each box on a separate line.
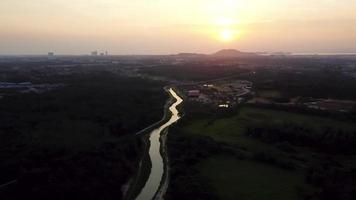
[0, 0, 356, 54]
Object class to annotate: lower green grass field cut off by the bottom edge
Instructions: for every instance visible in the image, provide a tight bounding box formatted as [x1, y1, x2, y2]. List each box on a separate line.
[198, 156, 303, 200]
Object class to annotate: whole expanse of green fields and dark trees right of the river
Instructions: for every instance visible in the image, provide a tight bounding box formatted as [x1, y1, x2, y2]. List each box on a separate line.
[167, 103, 356, 200]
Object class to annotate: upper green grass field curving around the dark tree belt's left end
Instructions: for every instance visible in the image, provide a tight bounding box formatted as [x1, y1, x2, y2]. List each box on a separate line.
[184, 107, 356, 149]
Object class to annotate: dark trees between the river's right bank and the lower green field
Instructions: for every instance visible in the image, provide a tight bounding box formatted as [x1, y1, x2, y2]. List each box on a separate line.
[166, 128, 221, 200]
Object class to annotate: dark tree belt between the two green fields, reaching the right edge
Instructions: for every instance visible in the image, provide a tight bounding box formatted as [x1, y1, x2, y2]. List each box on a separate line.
[246, 122, 356, 154]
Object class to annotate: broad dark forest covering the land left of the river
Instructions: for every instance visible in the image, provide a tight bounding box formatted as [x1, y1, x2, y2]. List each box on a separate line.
[0, 72, 167, 199]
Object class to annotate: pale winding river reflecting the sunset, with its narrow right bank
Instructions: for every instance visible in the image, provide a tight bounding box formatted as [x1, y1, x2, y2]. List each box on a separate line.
[136, 88, 183, 200]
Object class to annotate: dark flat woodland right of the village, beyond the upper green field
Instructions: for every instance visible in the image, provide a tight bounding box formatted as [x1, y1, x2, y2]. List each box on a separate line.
[249, 67, 356, 99]
